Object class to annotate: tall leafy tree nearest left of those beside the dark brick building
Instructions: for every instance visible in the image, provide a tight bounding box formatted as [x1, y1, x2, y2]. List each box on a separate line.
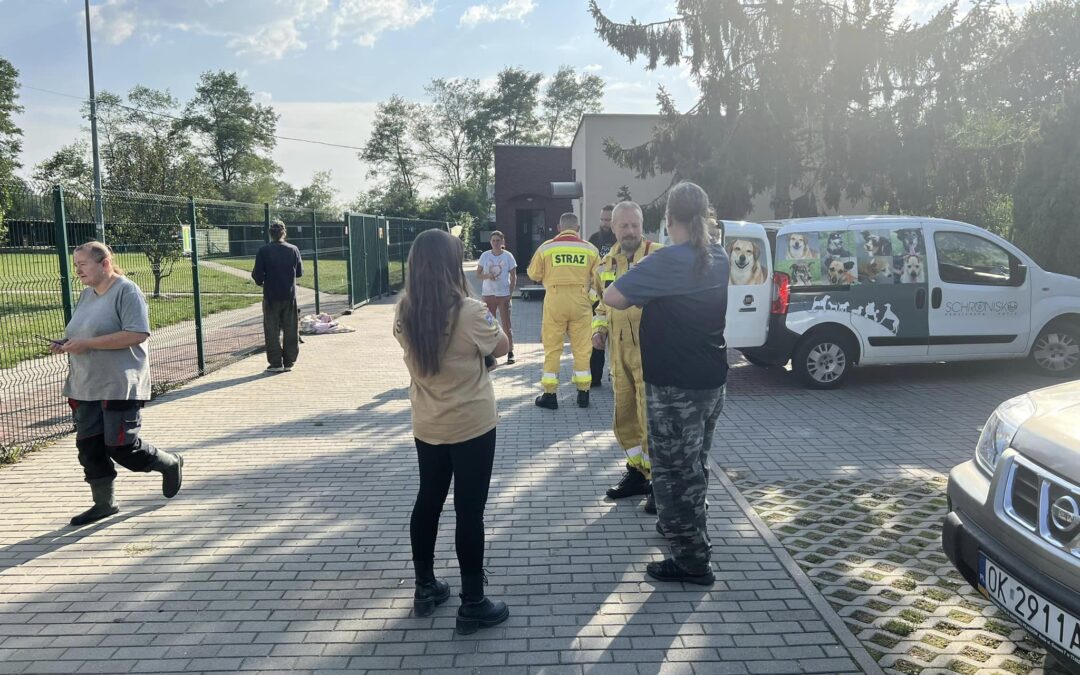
[360, 95, 422, 200]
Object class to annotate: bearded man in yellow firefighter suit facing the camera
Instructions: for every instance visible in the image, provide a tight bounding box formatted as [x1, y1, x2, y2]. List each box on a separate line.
[593, 202, 660, 513]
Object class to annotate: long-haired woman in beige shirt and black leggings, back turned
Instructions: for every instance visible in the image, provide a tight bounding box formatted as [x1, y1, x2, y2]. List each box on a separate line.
[394, 230, 510, 635]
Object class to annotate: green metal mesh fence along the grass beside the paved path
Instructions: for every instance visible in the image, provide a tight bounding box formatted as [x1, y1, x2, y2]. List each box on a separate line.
[0, 184, 447, 461]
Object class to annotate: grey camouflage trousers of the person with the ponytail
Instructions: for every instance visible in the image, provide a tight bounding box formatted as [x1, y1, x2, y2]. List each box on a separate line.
[645, 383, 726, 573]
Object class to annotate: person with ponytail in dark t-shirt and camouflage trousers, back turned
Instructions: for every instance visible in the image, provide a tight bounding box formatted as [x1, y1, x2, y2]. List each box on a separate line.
[604, 183, 729, 585]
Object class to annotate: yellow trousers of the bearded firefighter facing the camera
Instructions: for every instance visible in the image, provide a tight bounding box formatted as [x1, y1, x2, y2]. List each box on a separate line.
[607, 329, 652, 478]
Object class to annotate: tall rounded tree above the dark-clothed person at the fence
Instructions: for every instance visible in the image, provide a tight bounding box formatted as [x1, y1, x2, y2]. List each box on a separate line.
[178, 70, 280, 201]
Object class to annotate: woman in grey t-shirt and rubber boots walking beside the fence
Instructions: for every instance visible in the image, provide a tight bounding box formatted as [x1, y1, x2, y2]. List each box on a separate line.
[51, 242, 184, 526]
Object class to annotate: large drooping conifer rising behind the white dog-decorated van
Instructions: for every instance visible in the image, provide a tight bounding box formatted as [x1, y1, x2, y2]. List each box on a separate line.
[590, 0, 994, 217]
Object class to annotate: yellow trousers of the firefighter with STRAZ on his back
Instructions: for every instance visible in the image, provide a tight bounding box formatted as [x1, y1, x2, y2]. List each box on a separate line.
[540, 285, 593, 394]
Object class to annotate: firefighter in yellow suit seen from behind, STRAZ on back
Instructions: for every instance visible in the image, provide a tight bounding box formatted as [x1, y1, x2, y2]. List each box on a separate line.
[528, 213, 599, 410]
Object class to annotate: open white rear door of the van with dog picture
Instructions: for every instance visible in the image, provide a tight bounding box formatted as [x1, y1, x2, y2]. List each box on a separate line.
[724, 220, 772, 349]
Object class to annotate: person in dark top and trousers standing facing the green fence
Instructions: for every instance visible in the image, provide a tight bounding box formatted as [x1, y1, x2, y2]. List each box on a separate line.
[252, 220, 303, 373]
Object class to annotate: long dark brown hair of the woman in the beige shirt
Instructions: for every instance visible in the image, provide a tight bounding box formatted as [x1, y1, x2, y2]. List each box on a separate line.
[399, 224, 469, 377]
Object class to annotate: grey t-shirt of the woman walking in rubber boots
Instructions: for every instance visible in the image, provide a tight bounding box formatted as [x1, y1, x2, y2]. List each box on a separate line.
[64, 276, 150, 401]
